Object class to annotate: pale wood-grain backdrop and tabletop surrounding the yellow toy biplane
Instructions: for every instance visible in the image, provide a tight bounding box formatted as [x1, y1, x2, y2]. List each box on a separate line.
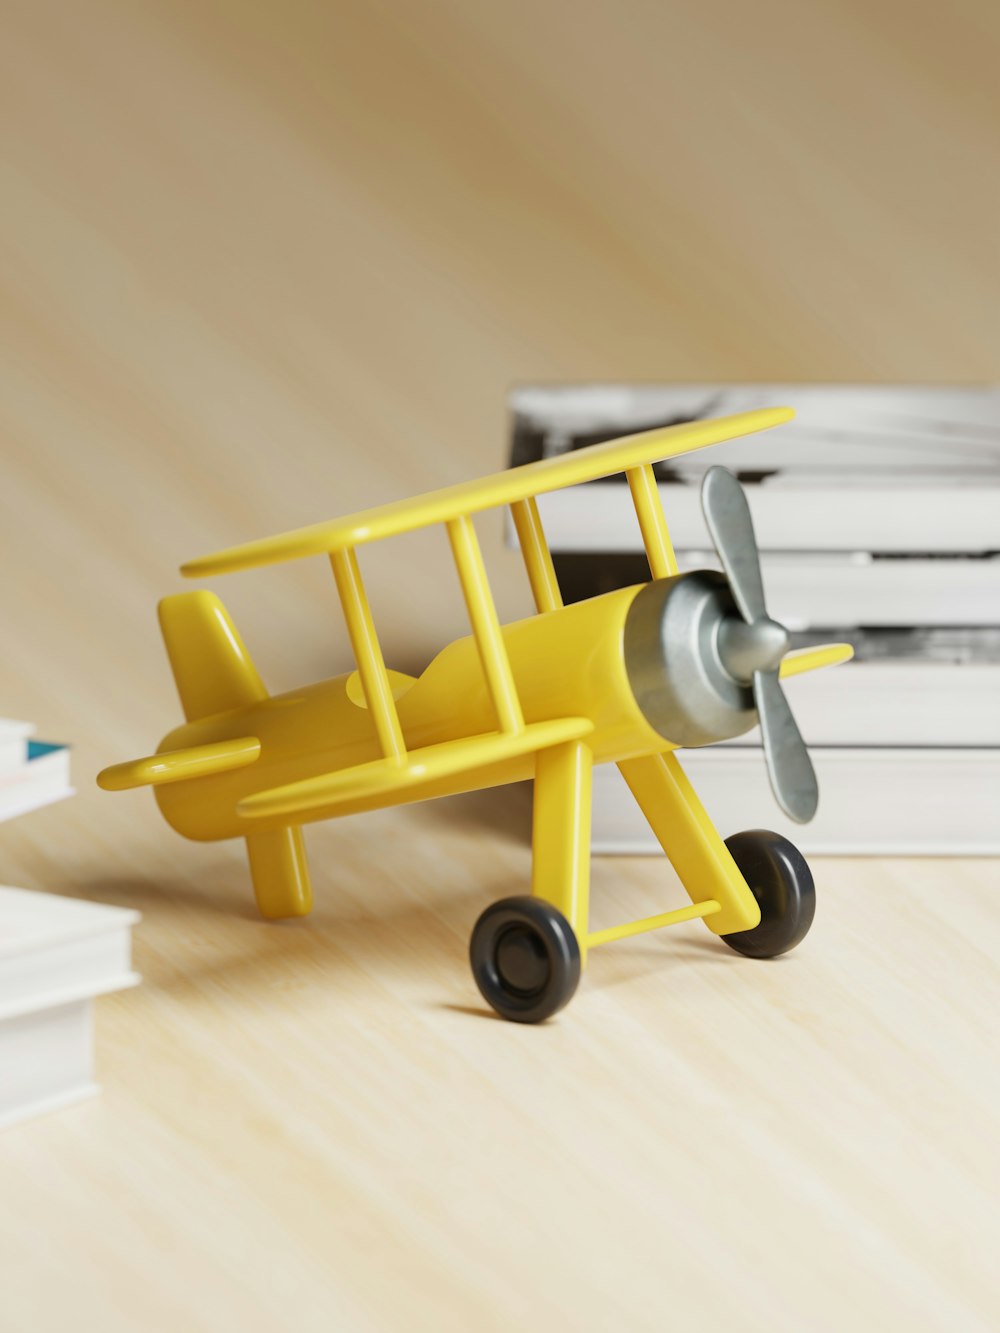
[0, 0, 1000, 1333]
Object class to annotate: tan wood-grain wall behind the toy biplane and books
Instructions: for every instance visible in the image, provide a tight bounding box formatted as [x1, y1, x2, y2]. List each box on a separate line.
[0, 0, 1000, 751]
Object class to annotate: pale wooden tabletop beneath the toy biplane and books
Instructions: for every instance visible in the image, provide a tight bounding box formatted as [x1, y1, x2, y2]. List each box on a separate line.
[0, 788, 1000, 1333]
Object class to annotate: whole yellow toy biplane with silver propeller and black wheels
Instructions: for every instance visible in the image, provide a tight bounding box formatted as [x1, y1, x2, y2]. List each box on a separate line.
[97, 408, 851, 1022]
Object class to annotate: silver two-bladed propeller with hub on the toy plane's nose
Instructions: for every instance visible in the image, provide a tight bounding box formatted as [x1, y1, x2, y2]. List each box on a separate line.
[701, 467, 820, 824]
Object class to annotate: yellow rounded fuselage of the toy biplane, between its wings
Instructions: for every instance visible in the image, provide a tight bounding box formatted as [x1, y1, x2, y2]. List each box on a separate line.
[156, 588, 672, 841]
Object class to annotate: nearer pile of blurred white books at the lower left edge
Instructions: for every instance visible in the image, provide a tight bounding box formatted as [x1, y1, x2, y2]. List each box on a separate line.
[0, 888, 139, 1128]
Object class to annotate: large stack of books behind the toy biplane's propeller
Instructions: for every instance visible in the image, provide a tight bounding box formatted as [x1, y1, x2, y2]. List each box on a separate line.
[511, 384, 1000, 856]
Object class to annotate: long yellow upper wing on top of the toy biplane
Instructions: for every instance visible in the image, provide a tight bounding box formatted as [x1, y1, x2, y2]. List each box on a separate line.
[181, 408, 795, 579]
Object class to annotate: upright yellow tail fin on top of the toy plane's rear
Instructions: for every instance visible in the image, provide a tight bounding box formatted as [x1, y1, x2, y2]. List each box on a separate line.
[159, 591, 268, 722]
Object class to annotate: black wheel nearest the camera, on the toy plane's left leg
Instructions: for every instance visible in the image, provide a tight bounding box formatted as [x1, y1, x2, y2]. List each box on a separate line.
[469, 897, 580, 1022]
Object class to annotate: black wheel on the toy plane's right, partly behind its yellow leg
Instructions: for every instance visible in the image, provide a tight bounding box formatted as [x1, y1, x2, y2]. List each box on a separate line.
[721, 829, 816, 958]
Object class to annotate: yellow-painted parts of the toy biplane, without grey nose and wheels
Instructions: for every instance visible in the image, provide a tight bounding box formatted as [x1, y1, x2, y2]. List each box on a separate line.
[99, 408, 851, 981]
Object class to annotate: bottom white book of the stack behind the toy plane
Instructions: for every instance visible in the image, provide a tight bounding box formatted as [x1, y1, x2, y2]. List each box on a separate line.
[592, 745, 1000, 856]
